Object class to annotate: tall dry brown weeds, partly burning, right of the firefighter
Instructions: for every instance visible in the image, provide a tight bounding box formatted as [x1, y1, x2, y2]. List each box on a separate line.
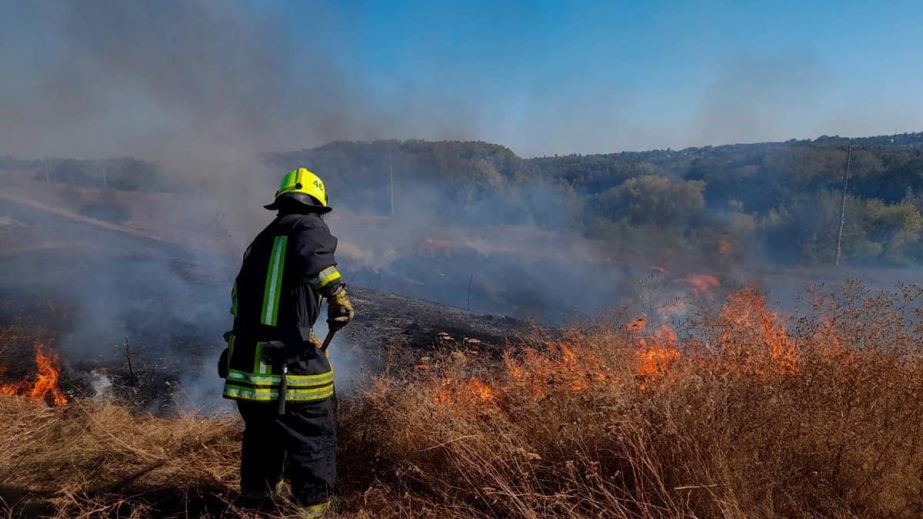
[341, 284, 923, 517]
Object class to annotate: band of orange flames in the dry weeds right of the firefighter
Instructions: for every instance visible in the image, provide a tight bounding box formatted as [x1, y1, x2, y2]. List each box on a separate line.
[427, 286, 808, 412]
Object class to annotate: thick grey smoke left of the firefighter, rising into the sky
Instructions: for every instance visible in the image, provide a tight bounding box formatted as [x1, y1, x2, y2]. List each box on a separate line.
[0, 0, 506, 411]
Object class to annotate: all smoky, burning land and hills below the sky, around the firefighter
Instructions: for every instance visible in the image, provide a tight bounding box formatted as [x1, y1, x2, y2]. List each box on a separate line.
[0, 137, 923, 518]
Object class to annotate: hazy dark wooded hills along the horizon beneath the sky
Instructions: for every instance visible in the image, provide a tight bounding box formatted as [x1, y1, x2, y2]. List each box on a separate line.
[9, 133, 923, 266]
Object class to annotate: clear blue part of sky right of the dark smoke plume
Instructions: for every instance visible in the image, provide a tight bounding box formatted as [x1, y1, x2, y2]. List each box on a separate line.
[284, 1, 923, 155]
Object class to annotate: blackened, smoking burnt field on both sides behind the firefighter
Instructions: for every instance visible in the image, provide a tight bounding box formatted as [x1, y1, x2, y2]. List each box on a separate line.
[0, 186, 533, 412]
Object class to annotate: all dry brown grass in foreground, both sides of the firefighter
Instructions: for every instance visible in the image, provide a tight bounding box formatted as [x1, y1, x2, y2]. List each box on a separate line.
[0, 285, 923, 518]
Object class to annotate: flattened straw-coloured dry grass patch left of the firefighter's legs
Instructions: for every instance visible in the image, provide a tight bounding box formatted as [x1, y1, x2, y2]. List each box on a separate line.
[0, 397, 239, 517]
